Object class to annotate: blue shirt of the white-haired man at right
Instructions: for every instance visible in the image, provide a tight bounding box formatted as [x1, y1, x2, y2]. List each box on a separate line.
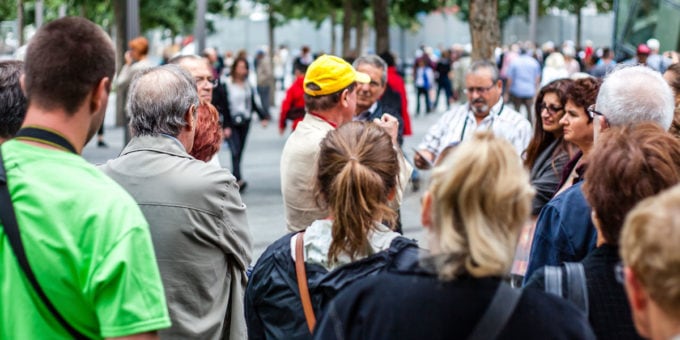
[524, 181, 597, 284]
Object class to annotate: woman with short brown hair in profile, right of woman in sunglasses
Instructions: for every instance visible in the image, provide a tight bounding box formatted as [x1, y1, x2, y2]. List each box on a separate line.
[554, 77, 602, 196]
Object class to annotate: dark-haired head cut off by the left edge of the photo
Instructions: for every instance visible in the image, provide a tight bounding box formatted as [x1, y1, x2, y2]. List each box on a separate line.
[0, 60, 27, 144]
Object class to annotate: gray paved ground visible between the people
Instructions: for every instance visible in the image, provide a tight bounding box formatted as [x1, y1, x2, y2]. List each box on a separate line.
[83, 88, 456, 259]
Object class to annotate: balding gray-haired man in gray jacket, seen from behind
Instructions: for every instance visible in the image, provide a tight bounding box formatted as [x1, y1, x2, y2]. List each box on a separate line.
[101, 65, 252, 339]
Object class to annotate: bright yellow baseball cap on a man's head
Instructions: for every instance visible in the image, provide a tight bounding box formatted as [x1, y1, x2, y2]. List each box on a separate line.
[303, 54, 371, 96]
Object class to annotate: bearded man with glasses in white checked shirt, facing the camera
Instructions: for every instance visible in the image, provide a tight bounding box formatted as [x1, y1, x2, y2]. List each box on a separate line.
[414, 60, 532, 169]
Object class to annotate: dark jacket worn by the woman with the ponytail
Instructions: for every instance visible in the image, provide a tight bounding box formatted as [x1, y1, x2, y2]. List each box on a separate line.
[245, 233, 418, 340]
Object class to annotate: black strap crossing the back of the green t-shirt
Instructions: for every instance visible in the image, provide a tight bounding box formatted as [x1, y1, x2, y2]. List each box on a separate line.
[0, 152, 87, 339]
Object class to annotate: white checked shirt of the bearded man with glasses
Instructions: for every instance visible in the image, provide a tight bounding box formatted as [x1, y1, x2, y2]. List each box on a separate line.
[418, 99, 532, 156]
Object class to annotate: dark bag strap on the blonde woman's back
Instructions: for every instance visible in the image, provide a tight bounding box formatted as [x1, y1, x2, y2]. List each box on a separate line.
[468, 281, 522, 340]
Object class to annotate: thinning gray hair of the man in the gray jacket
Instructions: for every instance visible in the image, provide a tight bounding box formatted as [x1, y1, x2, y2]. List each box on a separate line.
[127, 65, 199, 137]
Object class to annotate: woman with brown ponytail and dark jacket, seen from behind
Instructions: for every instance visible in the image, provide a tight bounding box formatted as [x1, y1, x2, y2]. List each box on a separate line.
[245, 122, 418, 339]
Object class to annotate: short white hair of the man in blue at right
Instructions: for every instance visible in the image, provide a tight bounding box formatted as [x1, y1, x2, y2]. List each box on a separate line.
[596, 66, 675, 130]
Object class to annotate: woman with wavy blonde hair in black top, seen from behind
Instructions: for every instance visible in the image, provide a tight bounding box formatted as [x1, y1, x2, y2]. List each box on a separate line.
[315, 132, 594, 339]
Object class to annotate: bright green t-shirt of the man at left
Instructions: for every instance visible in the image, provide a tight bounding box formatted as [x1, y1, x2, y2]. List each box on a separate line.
[0, 140, 170, 339]
